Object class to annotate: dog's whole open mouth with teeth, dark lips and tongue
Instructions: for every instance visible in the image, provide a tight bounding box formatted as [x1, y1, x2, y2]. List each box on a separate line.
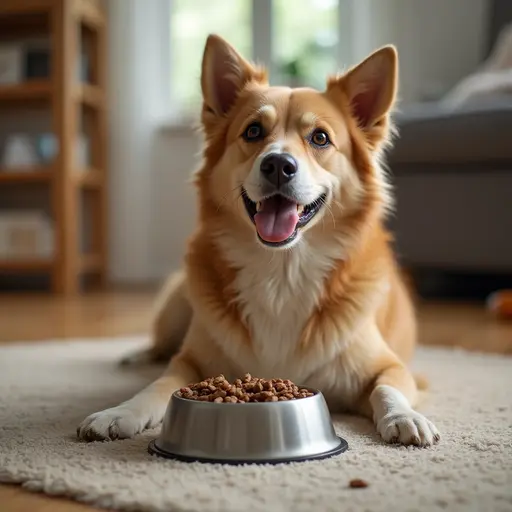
[242, 189, 326, 247]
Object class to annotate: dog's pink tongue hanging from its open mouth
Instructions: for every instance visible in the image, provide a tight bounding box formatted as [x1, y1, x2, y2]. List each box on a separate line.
[254, 196, 299, 242]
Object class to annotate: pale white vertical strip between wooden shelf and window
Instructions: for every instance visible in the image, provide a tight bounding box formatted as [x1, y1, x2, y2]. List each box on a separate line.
[107, 0, 168, 283]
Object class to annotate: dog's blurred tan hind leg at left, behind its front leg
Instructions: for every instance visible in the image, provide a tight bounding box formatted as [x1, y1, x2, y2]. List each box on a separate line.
[121, 272, 192, 365]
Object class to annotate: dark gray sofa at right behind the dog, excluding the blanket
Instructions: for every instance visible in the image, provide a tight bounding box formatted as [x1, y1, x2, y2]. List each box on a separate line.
[388, 0, 512, 297]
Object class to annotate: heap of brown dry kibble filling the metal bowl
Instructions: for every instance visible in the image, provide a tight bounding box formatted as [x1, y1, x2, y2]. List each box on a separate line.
[177, 373, 313, 404]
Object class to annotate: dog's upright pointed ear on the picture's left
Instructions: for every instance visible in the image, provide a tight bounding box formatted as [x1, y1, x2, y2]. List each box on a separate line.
[201, 34, 267, 116]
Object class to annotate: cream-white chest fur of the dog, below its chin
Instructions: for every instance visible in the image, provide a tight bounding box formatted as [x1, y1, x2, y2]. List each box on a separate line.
[217, 232, 340, 380]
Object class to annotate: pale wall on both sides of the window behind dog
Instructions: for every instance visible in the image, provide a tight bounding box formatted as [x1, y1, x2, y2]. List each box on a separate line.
[110, 0, 488, 282]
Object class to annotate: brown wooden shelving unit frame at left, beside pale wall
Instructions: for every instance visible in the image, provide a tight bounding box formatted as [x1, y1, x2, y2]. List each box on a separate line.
[0, 0, 107, 294]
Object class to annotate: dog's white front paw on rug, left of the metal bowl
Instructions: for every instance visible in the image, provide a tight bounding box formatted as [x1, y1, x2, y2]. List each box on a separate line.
[77, 405, 159, 441]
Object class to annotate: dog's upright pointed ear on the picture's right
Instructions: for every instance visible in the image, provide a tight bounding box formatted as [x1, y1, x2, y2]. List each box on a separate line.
[328, 45, 398, 131]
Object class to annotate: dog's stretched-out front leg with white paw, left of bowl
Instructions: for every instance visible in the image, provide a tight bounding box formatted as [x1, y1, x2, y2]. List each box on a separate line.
[77, 353, 200, 441]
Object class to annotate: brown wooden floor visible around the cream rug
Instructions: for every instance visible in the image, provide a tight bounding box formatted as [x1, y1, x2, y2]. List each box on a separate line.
[0, 290, 512, 512]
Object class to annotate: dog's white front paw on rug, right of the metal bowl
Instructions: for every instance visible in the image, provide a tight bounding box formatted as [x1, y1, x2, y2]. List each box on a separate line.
[377, 409, 440, 447]
